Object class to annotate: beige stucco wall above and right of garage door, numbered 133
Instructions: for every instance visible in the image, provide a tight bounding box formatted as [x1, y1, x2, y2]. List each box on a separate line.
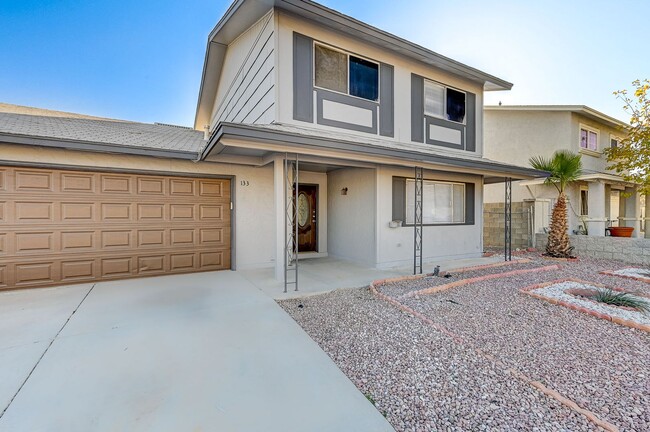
[0, 143, 275, 269]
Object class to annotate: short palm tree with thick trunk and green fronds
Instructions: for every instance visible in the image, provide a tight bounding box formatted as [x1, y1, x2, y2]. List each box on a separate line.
[529, 150, 582, 258]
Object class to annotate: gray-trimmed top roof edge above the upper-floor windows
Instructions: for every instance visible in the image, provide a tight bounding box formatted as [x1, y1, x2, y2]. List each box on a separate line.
[194, 0, 512, 130]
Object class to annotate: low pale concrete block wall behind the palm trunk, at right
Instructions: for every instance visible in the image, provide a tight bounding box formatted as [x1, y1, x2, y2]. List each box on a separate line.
[536, 234, 650, 266]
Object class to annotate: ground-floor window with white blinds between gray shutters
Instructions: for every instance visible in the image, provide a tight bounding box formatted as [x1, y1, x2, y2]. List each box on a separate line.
[406, 179, 465, 225]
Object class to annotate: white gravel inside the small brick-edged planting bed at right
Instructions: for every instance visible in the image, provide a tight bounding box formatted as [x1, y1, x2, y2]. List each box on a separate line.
[532, 281, 650, 325]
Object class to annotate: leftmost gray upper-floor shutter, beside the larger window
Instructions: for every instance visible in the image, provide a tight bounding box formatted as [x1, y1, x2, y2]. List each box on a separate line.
[293, 32, 314, 123]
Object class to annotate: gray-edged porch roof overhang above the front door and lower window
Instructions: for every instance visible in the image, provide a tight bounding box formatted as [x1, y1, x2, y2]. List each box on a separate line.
[200, 123, 548, 184]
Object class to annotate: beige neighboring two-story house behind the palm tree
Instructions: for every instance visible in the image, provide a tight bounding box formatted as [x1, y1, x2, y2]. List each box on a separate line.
[484, 105, 644, 237]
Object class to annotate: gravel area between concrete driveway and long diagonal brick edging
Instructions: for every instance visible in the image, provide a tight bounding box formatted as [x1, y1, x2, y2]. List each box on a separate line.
[279, 288, 596, 432]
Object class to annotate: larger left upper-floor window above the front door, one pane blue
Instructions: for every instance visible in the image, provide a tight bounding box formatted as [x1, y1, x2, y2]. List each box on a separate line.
[314, 44, 379, 101]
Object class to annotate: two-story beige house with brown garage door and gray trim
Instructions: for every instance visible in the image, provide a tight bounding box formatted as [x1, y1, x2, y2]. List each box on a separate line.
[0, 0, 543, 287]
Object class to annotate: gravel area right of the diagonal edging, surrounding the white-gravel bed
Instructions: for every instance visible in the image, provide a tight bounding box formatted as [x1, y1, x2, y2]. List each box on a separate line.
[392, 258, 650, 431]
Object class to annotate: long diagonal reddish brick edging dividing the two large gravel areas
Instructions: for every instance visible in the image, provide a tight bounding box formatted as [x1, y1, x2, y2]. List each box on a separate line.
[369, 272, 619, 432]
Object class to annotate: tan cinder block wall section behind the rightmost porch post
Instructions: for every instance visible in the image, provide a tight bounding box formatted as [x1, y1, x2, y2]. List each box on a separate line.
[483, 202, 532, 248]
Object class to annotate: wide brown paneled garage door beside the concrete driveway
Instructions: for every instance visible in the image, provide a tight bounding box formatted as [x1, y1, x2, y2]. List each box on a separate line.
[0, 167, 230, 289]
